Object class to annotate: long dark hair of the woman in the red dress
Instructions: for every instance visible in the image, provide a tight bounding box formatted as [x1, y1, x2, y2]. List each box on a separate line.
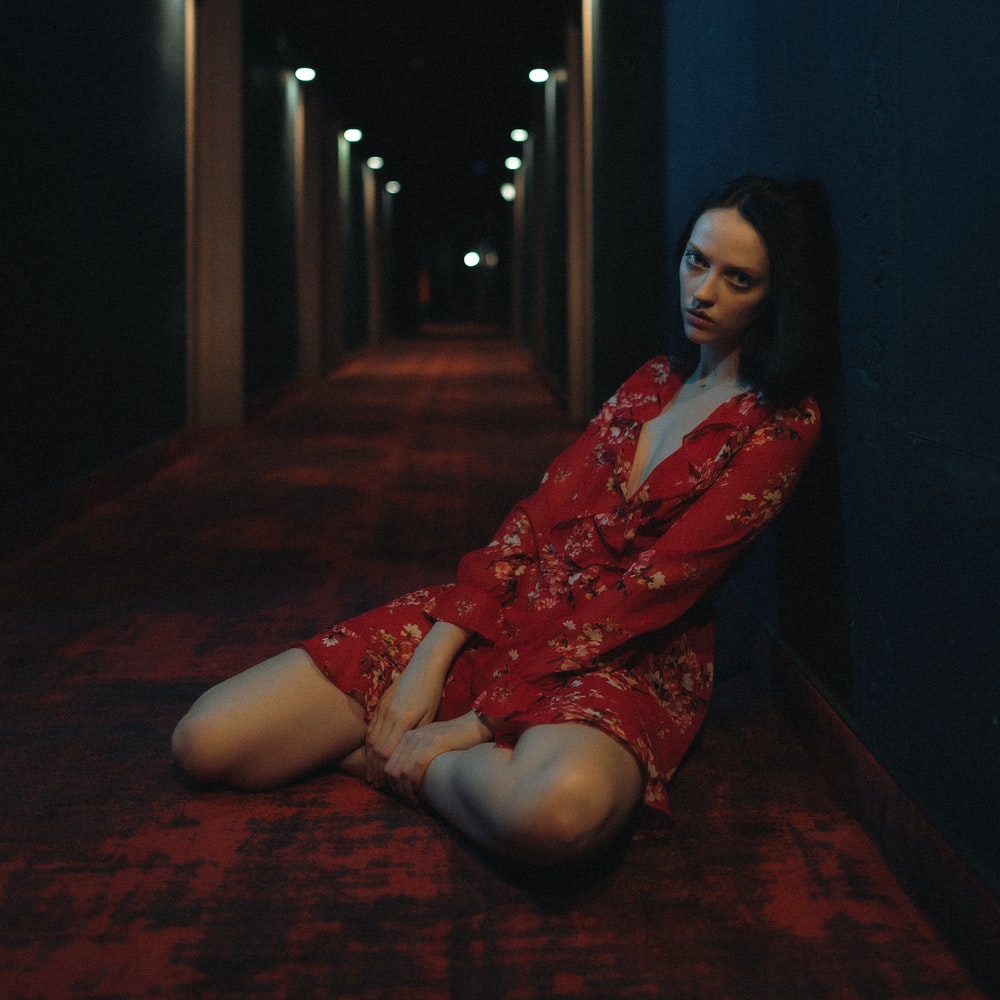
[676, 175, 839, 407]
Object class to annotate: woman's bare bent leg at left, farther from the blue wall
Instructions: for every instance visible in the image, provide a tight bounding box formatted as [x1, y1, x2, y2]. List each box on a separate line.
[173, 649, 365, 791]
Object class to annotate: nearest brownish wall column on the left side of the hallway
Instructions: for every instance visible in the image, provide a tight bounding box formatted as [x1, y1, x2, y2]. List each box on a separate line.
[185, 0, 245, 427]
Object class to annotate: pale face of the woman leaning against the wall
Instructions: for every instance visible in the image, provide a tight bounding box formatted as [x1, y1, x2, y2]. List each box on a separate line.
[680, 208, 770, 353]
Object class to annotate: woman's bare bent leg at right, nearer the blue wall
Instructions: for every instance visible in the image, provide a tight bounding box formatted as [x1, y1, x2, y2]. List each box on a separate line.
[423, 723, 643, 864]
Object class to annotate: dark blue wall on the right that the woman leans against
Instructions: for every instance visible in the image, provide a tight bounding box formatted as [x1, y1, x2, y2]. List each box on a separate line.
[664, 0, 1000, 887]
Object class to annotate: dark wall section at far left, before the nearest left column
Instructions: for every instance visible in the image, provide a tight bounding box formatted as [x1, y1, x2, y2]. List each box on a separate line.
[0, 0, 185, 509]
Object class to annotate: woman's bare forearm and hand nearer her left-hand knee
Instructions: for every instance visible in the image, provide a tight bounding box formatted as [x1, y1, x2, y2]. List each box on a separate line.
[365, 622, 469, 788]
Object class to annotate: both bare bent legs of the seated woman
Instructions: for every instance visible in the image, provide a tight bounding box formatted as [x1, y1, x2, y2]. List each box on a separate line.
[173, 649, 643, 864]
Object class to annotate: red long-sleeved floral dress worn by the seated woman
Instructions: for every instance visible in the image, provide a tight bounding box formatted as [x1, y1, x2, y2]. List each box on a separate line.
[303, 358, 820, 811]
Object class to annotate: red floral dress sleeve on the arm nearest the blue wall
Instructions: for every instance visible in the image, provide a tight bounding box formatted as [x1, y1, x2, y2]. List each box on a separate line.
[475, 405, 819, 717]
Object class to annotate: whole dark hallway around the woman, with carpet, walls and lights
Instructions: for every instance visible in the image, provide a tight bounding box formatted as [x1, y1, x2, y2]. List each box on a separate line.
[0, 0, 1000, 1000]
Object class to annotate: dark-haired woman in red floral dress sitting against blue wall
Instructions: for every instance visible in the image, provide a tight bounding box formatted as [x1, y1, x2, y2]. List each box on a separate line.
[173, 177, 836, 863]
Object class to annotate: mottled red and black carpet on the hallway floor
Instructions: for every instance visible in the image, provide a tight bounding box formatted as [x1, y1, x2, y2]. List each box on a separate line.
[0, 337, 985, 1000]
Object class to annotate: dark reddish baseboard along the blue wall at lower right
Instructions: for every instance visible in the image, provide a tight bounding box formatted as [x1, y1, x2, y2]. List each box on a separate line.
[769, 640, 1000, 996]
